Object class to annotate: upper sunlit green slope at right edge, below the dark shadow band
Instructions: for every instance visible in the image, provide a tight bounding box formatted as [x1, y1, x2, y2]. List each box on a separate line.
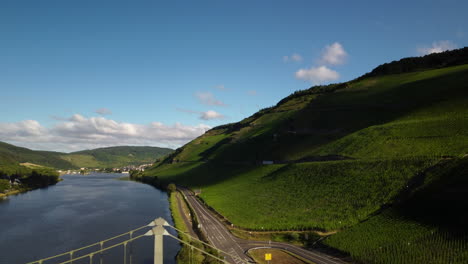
[311, 116, 468, 159]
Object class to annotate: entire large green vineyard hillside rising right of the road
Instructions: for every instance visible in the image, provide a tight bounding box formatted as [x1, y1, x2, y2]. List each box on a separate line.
[144, 48, 468, 263]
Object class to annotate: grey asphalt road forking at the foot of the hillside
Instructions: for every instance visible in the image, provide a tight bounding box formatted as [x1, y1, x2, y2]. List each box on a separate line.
[179, 188, 346, 264]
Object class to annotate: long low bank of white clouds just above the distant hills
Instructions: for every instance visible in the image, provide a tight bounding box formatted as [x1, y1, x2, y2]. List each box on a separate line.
[0, 114, 211, 151]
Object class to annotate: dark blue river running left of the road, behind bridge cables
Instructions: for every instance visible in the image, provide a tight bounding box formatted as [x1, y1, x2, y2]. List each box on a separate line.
[0, 174, 180, 264]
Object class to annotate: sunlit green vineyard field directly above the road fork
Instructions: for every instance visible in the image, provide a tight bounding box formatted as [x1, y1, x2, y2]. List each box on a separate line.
[196, 160, 431, 230]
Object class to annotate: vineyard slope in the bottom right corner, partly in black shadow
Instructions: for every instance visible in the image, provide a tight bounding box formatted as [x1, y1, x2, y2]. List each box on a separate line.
[325, 157, 468, 263]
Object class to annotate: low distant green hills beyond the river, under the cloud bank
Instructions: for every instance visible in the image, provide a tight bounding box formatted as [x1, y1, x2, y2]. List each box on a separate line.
[0, 142, 172, 169]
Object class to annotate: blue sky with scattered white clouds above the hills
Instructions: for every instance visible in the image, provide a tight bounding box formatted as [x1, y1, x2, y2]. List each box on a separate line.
[0, 0, 468, 151]
